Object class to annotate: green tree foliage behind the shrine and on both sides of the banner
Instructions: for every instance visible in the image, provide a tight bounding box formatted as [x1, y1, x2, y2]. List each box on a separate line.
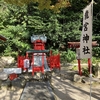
[0, 0, 100, 62]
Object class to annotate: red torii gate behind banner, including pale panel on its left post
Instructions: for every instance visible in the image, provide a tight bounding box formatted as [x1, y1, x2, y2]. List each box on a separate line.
[68, 41, 99, 76]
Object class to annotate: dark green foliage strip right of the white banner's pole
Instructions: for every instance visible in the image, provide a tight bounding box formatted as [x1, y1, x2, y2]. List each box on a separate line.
[93, 0, 100, 58]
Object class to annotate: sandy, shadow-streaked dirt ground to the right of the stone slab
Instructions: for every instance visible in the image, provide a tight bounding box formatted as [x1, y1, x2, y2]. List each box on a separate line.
[52, 69, 100, 100]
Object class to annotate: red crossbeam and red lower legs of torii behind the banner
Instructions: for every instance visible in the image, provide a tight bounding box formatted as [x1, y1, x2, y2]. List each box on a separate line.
[68, 41, 99, 76]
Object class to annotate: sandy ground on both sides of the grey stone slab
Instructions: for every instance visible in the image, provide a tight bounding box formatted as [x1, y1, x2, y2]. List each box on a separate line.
[0, 66, 100, 100]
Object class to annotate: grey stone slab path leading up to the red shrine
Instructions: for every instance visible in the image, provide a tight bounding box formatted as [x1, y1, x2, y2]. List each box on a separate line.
[20, 81, 55, 100]
